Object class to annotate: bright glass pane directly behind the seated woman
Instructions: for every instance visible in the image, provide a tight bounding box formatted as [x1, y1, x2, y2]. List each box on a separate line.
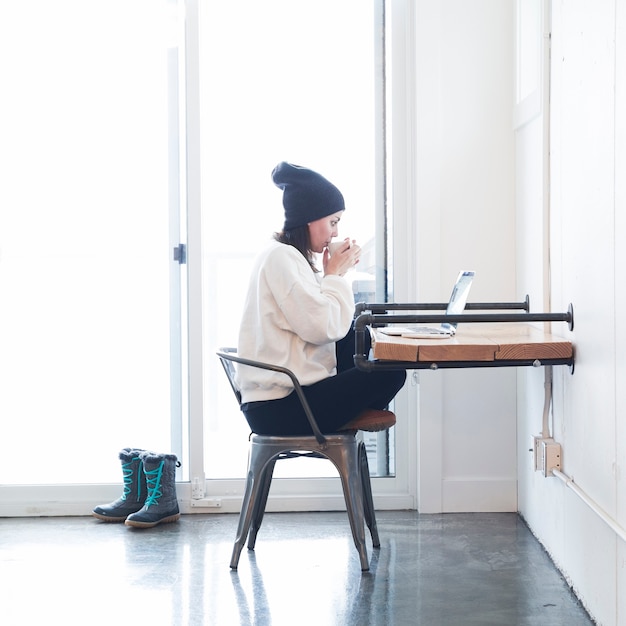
[200, 0, 394, 479]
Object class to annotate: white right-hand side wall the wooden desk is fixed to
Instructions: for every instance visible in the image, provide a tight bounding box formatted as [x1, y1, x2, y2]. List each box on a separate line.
[517, 0, 626, 625]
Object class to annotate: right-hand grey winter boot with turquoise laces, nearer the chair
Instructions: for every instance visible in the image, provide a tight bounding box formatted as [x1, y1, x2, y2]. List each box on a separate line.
[125, 452, 180, 528]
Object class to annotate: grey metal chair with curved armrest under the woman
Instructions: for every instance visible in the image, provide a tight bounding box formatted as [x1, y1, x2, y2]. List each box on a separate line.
[217, 348, 380, 571]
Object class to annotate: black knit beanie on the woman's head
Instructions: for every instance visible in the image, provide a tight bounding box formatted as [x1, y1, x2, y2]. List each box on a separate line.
[272, 161, 346, 230]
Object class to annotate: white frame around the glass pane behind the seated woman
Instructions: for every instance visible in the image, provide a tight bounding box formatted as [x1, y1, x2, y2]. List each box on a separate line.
[179, 0, 418, 513]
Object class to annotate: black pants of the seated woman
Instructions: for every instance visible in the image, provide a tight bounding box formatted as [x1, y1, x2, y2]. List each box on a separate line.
[242, 330, 406, 436]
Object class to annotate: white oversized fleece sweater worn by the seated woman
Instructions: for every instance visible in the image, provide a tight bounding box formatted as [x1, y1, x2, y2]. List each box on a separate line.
[237, 241, 354, 402]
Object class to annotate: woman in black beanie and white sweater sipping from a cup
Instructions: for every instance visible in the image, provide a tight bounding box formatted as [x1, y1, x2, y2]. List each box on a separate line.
[237, 162, 406, 436]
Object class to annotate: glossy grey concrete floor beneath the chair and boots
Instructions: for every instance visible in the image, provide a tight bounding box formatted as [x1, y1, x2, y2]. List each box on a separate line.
[0, 511, 593, 626]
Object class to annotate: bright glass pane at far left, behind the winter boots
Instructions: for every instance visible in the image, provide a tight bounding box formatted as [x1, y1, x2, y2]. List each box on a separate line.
[0, 0, 185, 485]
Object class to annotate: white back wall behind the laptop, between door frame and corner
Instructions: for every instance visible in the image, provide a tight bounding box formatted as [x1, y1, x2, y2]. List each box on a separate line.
[410, 0, 525, 513]
